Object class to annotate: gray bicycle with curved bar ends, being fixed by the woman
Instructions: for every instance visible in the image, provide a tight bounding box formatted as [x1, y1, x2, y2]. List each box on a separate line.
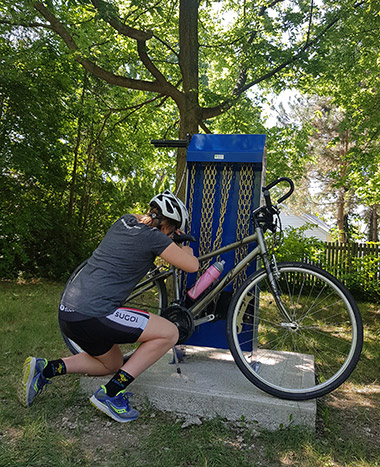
[64, 177, 363, 400]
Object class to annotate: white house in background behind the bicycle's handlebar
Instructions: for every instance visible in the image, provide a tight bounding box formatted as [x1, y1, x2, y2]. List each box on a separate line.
[280, 204, 332, 242]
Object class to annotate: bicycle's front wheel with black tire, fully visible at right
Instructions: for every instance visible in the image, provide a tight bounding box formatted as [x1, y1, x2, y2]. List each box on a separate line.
[227, 263, 363, 400]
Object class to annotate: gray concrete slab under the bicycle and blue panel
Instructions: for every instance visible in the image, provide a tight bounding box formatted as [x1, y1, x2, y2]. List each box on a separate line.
[81, 346, 316, 430]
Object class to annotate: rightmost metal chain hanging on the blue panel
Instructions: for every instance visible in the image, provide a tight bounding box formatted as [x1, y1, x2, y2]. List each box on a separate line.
[234, 164, 255, 292]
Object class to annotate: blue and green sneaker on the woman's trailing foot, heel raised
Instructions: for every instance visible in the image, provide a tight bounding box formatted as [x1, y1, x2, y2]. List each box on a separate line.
[19, 357, 51, 407]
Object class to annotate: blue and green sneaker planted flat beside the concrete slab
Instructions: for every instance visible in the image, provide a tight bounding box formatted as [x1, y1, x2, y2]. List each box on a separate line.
[90, 386, 139, 423]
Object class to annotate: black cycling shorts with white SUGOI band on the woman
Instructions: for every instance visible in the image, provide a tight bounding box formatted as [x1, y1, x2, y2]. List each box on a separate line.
[59, 308, 149, 357]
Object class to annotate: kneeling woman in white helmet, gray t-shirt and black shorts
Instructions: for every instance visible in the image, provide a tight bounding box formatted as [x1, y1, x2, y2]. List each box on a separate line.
[20, 190, 199, 422]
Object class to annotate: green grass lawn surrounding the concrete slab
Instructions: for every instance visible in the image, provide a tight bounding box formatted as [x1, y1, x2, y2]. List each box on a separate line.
[0, 282, 380, 467]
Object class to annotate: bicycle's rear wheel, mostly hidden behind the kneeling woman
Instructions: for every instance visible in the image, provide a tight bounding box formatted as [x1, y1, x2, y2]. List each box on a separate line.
[61, 277, 168, 358]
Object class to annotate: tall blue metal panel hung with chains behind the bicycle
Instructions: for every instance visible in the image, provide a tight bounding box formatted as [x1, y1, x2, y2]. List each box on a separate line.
[186, 134, 265, 348]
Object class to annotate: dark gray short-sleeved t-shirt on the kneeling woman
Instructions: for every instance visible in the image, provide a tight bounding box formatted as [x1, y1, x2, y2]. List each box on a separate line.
[60, 214, 172, 321]
